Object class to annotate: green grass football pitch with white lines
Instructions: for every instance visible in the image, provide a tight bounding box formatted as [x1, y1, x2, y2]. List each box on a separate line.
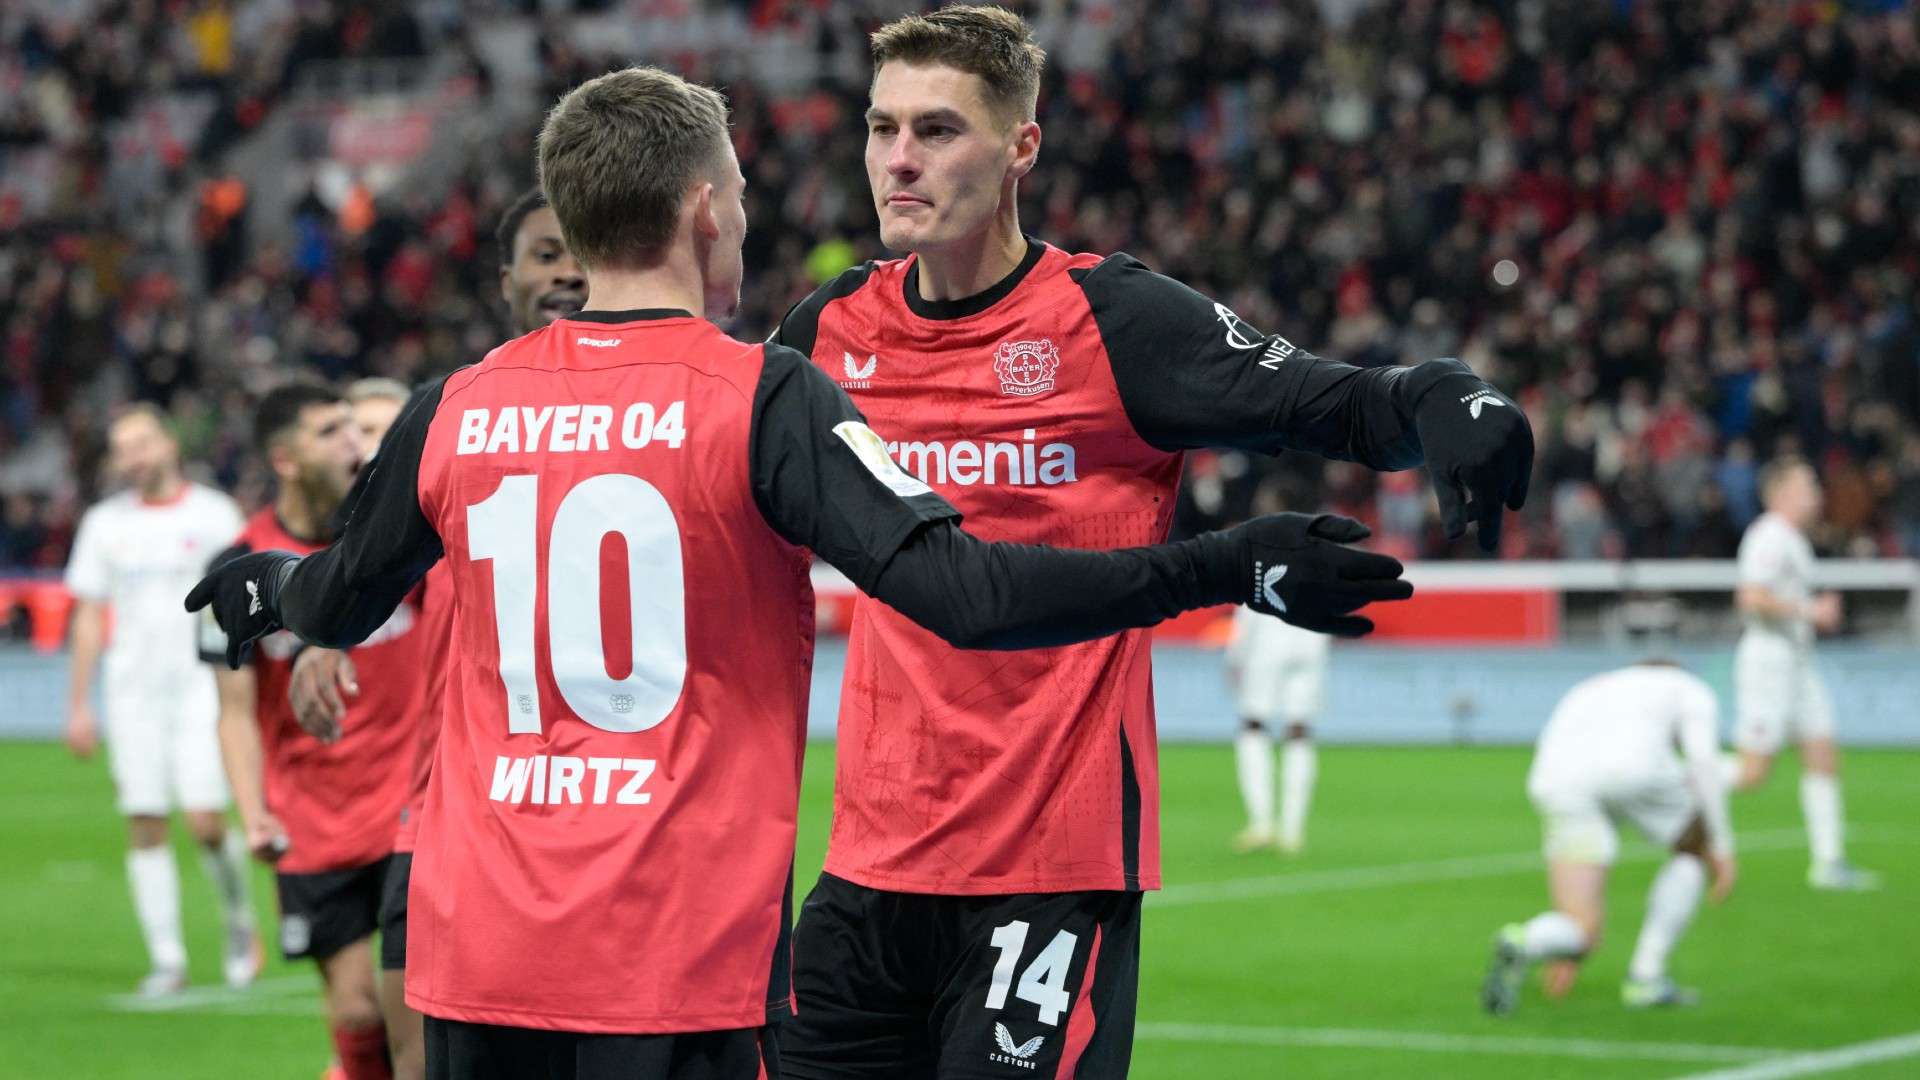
[0, 744, 1920, 1080]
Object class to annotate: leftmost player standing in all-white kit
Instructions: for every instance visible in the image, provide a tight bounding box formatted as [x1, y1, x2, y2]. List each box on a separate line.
[67, 404, 261, 995]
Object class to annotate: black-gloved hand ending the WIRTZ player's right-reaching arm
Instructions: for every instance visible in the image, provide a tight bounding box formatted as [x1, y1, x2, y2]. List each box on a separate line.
[1227, 513, 1413, 638]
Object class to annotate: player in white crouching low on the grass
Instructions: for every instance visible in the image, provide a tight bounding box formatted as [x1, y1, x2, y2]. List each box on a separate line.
[1480, 661, 1736, 1015]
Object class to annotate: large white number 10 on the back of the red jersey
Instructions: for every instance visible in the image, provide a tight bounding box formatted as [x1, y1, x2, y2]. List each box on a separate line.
[467, 473, 687, 734]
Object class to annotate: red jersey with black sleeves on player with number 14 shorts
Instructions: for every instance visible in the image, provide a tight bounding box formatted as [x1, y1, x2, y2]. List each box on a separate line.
[772, 242, 1421, 896]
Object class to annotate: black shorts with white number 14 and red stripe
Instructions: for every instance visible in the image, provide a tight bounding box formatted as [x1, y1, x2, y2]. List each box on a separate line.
[780, 874, 1142, 1080]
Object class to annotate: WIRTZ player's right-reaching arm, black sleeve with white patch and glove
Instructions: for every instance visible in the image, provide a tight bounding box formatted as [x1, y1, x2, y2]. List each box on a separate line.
[749, 346, 1411, 650]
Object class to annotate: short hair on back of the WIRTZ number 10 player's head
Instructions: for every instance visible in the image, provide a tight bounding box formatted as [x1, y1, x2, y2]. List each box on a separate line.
[540, 67, 728, 271]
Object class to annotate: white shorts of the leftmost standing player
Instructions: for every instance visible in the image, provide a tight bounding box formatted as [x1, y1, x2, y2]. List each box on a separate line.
[102, 673, 228, 817]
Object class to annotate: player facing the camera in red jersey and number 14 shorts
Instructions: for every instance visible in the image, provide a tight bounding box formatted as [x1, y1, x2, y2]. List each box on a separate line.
[770, 8, 1532, 1078]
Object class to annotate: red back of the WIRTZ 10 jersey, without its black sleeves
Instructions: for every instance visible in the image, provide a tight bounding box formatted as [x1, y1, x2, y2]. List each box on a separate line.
[403, 313, 817, 1034]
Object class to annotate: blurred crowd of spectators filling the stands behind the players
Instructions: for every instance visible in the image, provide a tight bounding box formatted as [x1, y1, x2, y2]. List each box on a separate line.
[0, 0, 1920, 569]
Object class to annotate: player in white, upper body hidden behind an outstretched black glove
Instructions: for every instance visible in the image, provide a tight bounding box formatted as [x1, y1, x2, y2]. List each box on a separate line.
[1227, 607, 1332, 855]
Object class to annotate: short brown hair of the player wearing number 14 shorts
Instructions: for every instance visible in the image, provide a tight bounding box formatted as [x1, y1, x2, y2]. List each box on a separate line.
[870, 4, 1046, 121]
